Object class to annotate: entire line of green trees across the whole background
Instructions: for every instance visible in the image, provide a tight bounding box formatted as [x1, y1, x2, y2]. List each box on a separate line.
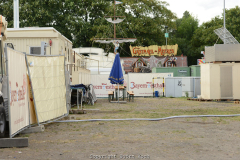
[0, 0, 240, 65]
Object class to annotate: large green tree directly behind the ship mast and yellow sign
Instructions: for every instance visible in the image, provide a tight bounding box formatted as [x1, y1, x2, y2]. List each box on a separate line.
[95, 0, 176, 56]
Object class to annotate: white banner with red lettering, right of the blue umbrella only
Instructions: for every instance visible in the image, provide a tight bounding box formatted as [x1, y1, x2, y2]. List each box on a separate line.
[128, 73, 173, 96]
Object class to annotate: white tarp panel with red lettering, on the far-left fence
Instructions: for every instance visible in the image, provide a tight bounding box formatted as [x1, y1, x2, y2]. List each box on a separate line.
[7, 48, 29, 137]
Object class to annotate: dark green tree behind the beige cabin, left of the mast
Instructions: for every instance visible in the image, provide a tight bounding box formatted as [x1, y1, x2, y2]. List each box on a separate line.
[0, 0, 110, 47]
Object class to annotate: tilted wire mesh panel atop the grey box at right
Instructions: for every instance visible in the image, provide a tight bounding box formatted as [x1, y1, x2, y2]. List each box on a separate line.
[214, 27, 239, 44]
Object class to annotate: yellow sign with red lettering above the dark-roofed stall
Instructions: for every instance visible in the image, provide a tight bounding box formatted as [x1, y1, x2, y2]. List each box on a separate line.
[130, 44, 178, 57]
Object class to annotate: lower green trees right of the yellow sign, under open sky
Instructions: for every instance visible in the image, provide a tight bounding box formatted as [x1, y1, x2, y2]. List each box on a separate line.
[171, 6, 240, 65]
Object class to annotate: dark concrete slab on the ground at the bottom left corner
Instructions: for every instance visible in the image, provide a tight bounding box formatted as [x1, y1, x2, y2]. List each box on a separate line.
[0, 138, 28, 148]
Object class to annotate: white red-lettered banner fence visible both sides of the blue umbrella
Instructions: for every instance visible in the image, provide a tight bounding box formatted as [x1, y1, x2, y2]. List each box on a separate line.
[91, 73, 173, 97]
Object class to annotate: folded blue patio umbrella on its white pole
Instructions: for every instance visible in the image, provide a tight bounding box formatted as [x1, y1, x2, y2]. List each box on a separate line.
[108, 53, 124, 101]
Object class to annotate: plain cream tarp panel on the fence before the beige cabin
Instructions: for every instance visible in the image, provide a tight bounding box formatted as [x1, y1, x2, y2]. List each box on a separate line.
[27, 55, 67, 123]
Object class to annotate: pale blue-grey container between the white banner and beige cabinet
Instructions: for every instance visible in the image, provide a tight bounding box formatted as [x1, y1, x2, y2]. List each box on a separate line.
[165, 77, 201, 97]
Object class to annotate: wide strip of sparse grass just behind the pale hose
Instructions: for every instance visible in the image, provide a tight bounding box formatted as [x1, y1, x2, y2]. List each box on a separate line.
[71, 97, 240, 121]
